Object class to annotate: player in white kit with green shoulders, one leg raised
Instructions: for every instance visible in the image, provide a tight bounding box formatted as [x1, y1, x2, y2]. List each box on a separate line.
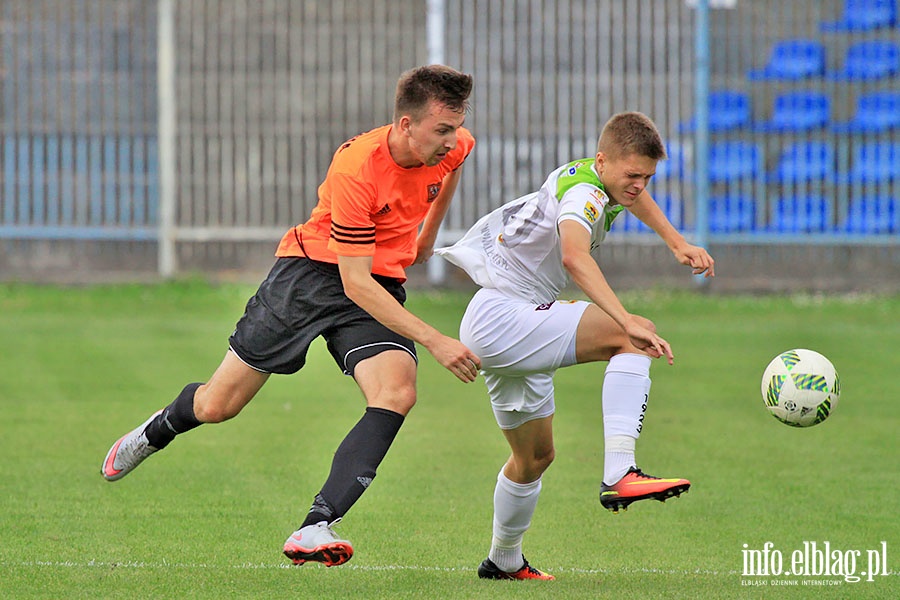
[436, 112, 715, 579]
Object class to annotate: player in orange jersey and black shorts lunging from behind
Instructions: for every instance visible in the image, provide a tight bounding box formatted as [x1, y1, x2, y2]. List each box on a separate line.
[102, 65, 481, 566]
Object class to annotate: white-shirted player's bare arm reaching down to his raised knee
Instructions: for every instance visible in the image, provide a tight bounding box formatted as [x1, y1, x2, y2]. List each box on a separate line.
[558, 220, 674, 364]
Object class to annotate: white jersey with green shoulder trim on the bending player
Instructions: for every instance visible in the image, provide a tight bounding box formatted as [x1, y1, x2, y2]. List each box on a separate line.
[435, 158, 623, 304]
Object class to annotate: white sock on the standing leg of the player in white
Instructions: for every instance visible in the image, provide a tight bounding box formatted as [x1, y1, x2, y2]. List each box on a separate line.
[488, 469, 541, 573]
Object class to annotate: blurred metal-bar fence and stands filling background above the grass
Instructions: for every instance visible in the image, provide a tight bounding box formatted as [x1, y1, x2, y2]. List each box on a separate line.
[0, 0, 900, 290]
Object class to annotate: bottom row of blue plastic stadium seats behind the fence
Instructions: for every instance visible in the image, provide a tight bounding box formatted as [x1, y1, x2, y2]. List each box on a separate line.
[612, 194, 900, 235]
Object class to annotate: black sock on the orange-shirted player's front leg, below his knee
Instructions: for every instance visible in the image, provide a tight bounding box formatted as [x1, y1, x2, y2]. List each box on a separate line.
[301, 407, 403, 527]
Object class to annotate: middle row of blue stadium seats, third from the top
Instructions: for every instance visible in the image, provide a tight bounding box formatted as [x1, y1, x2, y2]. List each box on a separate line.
[679, 90, 900, 133]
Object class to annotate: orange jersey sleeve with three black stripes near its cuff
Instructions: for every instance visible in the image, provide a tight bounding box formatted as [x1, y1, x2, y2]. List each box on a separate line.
[328, 174, 376, 256]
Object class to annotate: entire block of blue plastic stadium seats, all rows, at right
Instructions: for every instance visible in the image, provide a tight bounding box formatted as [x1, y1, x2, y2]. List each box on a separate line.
[640, 0, 900, 235]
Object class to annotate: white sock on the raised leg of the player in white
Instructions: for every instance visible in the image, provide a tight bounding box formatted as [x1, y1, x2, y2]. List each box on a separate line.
[603, 354, 650, 485]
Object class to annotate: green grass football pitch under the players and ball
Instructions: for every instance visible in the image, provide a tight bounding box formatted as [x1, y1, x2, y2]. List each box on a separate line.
[0, 282, 900, 600]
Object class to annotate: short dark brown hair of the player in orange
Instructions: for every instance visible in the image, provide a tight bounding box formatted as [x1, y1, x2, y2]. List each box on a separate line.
[394, 65, 473, 121]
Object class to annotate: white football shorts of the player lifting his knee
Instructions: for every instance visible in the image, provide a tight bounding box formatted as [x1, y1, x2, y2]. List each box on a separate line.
[459, 288, 589, 429]
